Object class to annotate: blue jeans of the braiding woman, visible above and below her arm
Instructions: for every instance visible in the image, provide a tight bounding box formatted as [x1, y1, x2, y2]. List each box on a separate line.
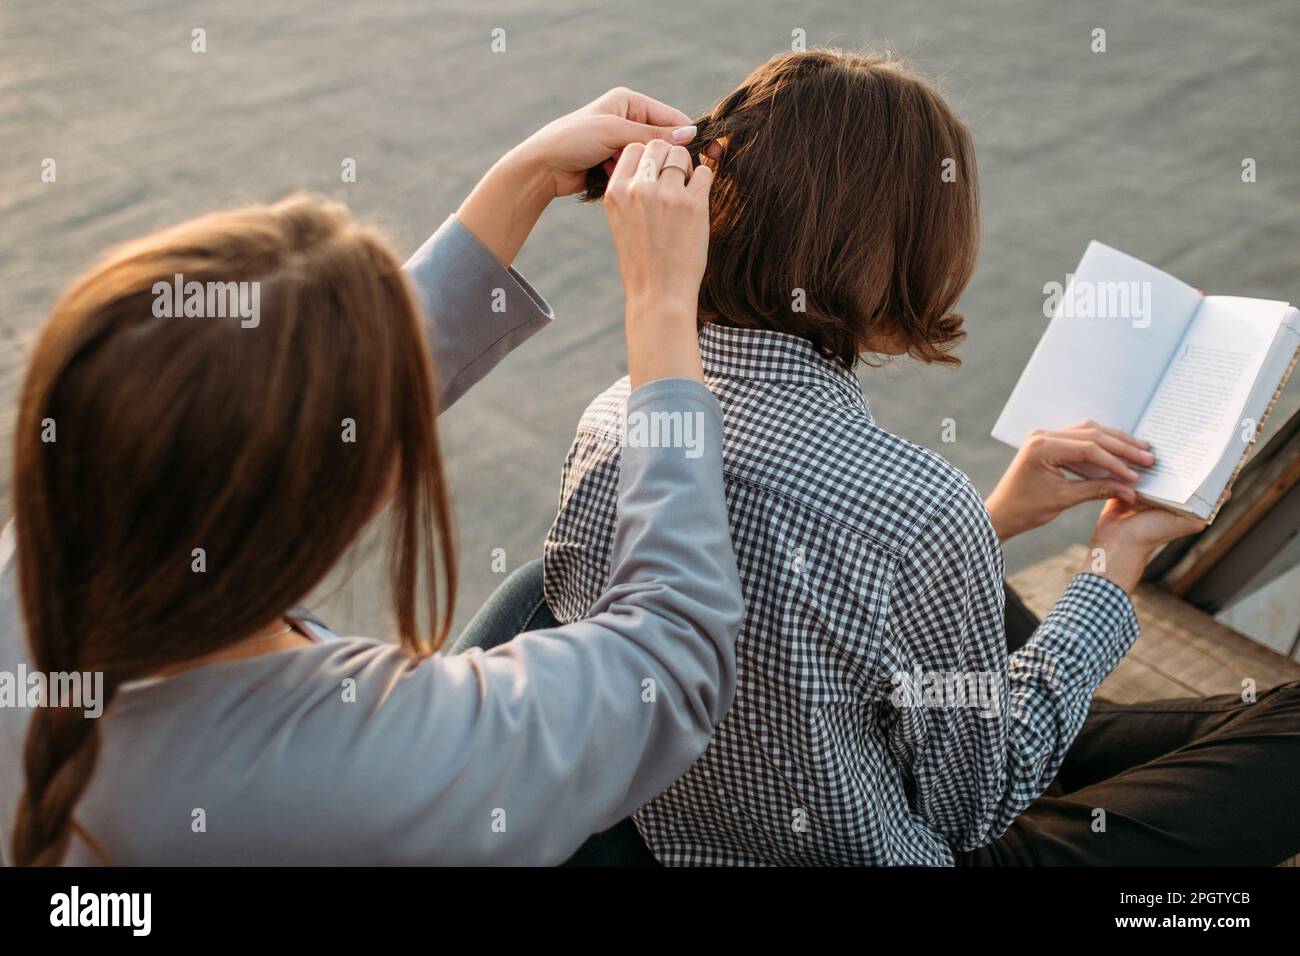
[447, 558, 658, 866]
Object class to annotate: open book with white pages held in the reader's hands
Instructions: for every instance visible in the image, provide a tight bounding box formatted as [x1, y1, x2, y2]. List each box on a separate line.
[993, 242, 1300, 520]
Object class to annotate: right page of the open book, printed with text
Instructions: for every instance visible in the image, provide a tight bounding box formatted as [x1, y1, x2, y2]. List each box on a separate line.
[1134, 295, 1287, 502]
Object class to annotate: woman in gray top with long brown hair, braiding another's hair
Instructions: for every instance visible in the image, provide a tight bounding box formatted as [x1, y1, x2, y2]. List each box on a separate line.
[0, 90, 741, 865]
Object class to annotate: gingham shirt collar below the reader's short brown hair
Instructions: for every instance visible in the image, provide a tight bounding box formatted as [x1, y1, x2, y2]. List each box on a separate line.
[699, 323, 867, 411]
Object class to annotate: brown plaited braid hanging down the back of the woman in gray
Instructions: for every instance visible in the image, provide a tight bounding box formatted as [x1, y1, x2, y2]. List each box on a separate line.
[13, 689, 113, 866]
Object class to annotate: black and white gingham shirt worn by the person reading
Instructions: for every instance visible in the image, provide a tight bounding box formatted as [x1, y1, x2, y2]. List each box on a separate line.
[546, 325, 1138, 865]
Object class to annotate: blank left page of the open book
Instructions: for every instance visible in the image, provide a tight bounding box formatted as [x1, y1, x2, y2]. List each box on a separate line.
[993, 242, 1203, 447]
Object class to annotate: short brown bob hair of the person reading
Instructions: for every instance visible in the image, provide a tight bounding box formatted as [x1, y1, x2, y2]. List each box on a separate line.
[587, 49, 979, 368]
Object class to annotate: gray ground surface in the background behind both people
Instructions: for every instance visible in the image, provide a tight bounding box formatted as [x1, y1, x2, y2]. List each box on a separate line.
[0, 0, 1300, 642]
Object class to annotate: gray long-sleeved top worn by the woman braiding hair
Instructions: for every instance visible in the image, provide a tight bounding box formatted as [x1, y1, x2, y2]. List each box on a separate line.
[0, 219, 742, 865]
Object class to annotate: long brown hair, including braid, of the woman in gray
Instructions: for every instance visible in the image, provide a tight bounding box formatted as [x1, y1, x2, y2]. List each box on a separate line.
[13, 198, 456, 864]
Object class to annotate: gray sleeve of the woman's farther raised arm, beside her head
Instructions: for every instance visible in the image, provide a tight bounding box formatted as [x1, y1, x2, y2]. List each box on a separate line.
[403, 216, 555, 414]
